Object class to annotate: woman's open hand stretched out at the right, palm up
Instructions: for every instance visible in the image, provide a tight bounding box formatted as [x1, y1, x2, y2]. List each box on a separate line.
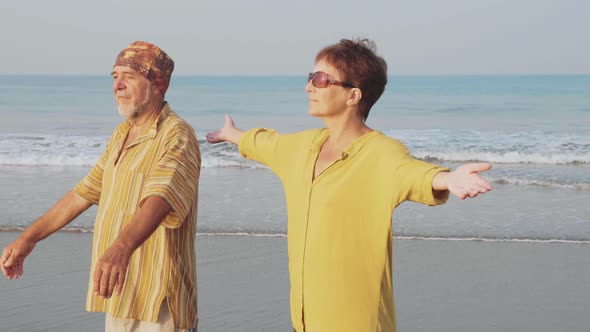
[432, 163, 492, 199]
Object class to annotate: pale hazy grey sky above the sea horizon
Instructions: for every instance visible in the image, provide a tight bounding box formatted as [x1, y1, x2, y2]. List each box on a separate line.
[0, 0, 590, 75]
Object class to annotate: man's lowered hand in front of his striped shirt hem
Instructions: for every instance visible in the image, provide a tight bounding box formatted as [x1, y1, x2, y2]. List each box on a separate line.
[94, 242, 133, 299]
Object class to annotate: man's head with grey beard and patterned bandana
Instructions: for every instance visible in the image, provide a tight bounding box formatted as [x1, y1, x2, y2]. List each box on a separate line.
[112, 41, 174, 117]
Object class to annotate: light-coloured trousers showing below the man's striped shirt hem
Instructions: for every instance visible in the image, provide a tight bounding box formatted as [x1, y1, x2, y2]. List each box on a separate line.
[104, 301, 197, 332]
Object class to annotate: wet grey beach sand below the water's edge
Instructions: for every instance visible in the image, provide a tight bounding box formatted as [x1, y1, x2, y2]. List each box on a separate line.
[0, 232, 590, 332]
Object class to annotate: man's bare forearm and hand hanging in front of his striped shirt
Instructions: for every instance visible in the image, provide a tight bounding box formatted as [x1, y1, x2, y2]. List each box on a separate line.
[94, 196, 171, 298]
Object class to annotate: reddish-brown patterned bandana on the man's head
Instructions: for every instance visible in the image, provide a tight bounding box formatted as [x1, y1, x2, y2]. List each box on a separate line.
[113, 41, 174, 95]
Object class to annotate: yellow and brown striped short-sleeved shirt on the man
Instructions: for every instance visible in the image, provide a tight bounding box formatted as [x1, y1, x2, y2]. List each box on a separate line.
[75, 103, 201, 329]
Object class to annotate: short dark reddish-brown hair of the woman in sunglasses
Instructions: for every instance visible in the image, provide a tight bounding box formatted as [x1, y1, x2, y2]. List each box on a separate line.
[315, 39, 387, 121]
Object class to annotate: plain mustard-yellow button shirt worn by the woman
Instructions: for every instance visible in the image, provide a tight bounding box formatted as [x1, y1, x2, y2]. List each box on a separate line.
[239, 129, 448, 332]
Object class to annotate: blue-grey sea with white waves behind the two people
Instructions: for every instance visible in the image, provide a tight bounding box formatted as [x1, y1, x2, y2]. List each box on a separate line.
[0, 74, 590, 243]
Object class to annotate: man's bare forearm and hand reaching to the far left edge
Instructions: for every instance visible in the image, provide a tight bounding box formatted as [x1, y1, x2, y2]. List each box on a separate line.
[0, 191, 92, 279]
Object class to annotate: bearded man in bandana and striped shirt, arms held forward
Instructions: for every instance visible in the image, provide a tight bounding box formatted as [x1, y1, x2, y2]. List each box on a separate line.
[0, 41, 201, 331]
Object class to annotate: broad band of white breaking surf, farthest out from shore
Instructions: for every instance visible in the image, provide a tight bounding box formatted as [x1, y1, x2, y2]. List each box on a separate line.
[0, 130, 590, 168]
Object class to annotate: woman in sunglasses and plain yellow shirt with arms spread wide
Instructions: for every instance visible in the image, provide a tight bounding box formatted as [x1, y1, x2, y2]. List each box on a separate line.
[207, 40, 492, 332]
